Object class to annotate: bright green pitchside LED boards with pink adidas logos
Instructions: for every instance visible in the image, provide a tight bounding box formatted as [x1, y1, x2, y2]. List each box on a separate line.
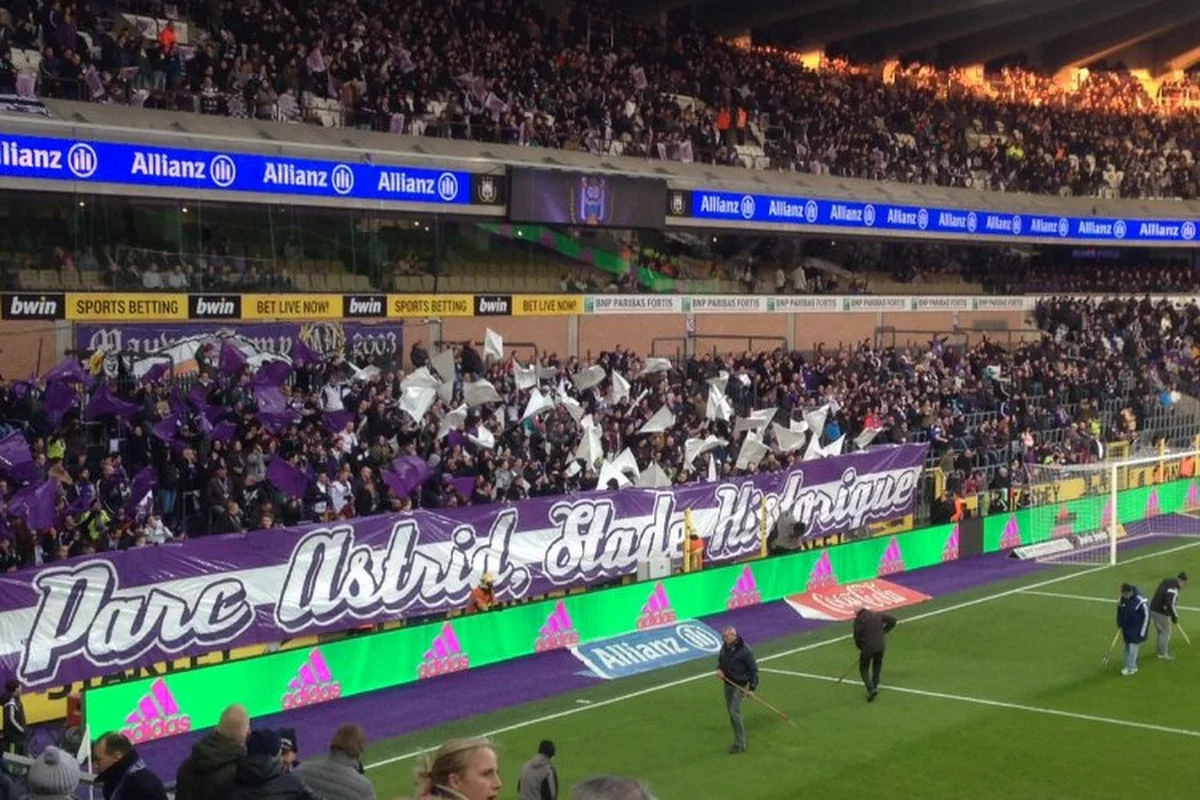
[84, 479, 1200, 742]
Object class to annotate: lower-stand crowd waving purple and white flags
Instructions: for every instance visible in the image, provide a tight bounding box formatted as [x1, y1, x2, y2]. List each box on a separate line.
[0, 293, 1200, 570]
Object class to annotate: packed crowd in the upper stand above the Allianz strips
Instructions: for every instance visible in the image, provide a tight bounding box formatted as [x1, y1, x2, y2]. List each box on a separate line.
[0, 0, 1200, 198]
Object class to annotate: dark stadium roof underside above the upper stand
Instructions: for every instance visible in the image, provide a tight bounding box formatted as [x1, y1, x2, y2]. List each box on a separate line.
[628, 0, 1200, 74]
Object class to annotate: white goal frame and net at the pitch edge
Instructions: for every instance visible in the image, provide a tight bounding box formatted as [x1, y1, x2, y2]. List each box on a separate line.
[1022, 451, 1200, 565]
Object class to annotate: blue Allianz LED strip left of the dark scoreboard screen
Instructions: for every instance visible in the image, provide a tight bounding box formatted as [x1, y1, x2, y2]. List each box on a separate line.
[0, 133, 505, 206]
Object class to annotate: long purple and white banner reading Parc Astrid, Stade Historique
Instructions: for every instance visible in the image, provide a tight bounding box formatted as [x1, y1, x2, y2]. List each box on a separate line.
[0, 445, 926, 688]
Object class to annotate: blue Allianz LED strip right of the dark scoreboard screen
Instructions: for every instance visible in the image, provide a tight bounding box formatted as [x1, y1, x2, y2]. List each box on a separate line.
[667, 190, 1196, 243]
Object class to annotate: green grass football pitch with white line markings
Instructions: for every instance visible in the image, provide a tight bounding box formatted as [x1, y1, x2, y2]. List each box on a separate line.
[367, 540, 1200, 800]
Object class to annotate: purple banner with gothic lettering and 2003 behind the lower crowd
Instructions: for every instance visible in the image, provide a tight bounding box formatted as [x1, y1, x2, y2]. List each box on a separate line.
[74, 321, 403, 361]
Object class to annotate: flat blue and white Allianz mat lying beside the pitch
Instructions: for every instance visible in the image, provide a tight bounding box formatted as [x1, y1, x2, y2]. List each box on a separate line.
[571, 620, 721, 680]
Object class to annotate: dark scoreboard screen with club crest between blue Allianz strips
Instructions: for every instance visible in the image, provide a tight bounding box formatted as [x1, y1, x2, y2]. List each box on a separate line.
[509, 169, 667, 228]
